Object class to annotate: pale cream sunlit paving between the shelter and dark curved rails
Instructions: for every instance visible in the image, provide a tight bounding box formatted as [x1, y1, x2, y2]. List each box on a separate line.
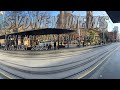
[0, 44, 112, 67]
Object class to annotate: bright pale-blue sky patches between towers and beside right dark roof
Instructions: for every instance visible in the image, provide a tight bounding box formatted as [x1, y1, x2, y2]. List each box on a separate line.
[52, 11, 120, 32]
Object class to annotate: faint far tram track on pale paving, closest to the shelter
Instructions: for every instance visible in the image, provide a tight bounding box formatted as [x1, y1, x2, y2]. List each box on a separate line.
[2, 46, 108, 60]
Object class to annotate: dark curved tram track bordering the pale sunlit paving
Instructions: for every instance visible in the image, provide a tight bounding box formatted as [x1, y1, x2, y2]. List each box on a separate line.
[0, 49, 109, 74]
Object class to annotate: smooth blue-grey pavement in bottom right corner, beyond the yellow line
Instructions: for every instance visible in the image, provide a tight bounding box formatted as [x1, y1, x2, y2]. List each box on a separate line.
[95, 43, 120, 79]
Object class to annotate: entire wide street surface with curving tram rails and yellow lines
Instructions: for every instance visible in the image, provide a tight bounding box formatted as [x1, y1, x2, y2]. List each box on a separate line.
[0, 43, 120, 79]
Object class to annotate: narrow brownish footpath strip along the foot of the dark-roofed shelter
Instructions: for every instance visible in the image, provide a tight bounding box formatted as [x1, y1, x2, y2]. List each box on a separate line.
[0, 44, 108, 55]
